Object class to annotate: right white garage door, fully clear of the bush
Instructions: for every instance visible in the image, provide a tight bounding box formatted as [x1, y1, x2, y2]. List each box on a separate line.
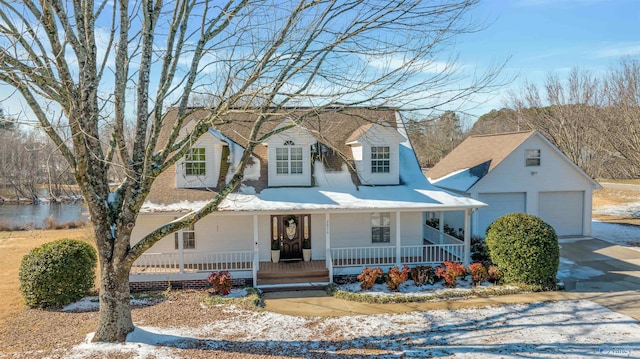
[538, 191, 584, 236]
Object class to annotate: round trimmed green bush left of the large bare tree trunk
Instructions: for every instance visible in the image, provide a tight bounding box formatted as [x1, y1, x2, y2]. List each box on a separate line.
[19, 239, 98, 308]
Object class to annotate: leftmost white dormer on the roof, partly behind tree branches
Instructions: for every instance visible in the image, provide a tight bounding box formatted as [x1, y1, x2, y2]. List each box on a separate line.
[176, 120, 228, 188]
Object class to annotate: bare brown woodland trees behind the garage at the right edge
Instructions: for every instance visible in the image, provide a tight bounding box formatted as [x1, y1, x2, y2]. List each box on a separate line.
[470, 59, 640, 178]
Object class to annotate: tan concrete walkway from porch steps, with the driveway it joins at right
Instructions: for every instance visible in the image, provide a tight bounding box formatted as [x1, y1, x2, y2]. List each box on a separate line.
[264, 239, 640, 321]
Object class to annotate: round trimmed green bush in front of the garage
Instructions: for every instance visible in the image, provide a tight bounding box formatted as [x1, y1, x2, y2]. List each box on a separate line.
[485, 213, 560, 289]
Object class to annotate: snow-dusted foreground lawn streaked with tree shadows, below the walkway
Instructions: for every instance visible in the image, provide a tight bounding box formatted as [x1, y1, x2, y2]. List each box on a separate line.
[67, 301, 640, 358]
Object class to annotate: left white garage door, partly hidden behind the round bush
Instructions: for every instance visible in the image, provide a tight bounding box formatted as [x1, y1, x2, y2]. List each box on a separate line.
[474, 192, 525, 237]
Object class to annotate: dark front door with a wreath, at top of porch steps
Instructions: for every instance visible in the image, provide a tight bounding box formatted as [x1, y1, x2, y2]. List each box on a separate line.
[271, 214, 309, 260]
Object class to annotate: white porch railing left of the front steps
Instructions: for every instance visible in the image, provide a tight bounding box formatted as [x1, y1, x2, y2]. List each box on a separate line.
[131, 251, 255, 274]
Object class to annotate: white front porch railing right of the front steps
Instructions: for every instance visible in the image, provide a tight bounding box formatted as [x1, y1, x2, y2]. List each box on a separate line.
[329, 241, 464, 268]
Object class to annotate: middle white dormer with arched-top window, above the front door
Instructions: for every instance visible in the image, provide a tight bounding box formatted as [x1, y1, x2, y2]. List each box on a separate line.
[265, 120, 316, 187]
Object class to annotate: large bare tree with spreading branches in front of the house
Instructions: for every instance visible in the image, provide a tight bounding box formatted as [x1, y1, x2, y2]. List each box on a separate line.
[0, 0, 499, 341]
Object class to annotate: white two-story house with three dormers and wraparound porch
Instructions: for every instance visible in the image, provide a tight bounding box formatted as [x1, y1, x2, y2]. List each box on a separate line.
[131, 108, 484, 289]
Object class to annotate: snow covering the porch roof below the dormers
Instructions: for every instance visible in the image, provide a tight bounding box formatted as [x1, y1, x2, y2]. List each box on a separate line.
[142, 115, 486, 212]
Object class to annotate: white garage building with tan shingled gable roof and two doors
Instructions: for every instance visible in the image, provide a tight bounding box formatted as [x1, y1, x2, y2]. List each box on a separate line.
[426, 130, 602, 236]
